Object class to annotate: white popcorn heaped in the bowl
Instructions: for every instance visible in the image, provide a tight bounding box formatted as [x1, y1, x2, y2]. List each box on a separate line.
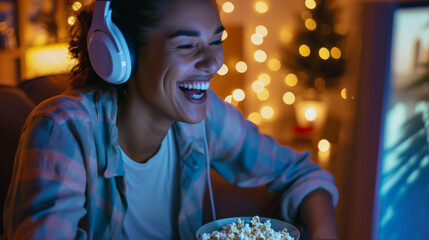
[200, 216, 294, 240]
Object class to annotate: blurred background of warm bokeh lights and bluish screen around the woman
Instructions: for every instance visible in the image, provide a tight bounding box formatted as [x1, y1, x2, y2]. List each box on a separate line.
[0, 0, 429, 240]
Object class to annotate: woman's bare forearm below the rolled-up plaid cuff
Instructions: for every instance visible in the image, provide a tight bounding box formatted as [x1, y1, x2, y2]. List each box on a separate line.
[298, 189, 339, 240]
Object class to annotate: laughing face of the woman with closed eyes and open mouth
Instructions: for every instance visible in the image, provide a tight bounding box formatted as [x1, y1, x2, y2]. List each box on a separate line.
[131, 0, 224, 123]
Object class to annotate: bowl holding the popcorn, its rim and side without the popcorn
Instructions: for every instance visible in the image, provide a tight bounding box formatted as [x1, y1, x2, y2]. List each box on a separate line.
[196, 217, 299, 240]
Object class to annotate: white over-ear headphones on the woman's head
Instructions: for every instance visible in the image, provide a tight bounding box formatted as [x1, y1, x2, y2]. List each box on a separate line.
[87, 0, 133, 84]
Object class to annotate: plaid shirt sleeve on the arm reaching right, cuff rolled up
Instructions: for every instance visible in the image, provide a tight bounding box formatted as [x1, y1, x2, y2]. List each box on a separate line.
[206, 92, 338, 222]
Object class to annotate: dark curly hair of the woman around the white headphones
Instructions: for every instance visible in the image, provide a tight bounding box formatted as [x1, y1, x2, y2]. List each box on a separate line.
[69, 0, 169, 101]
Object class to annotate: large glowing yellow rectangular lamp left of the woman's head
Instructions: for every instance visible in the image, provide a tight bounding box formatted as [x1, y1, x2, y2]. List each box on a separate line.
[24, 43, 76, 78]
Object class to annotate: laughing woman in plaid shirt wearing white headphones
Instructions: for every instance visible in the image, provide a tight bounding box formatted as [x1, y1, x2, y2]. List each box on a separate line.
[4, 0, 338, 239]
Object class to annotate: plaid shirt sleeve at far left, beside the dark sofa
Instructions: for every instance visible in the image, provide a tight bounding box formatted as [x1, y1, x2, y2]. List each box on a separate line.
[4, 116, 86, 239]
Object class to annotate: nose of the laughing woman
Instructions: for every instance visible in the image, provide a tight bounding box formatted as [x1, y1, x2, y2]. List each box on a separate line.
[195, 47, 223, 75]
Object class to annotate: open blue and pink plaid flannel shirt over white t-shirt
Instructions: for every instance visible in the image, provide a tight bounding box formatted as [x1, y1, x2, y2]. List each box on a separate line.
[4, 90, 338, 239]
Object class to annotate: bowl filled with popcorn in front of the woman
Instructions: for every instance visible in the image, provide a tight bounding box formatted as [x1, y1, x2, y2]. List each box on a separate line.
[196, 216, 299, 240]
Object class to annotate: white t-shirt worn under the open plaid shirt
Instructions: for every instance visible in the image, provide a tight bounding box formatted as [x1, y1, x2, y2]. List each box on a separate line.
[121, 129, 180, 240]
